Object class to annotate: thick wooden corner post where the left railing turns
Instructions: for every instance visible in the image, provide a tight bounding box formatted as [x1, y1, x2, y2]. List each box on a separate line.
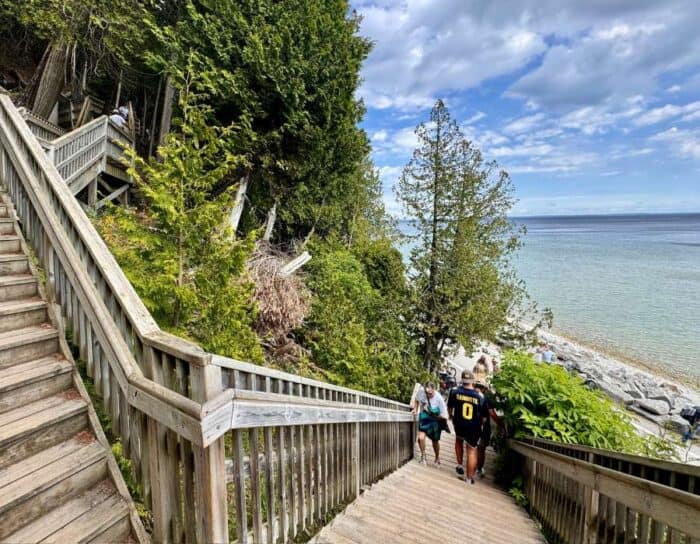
[192, 364, 228, 543]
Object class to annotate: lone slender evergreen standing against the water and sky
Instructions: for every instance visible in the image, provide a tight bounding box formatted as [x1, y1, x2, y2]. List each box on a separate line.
[398, 101, 524, 371]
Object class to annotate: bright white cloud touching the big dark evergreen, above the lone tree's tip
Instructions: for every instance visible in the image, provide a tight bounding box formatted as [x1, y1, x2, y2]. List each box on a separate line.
[355, 0, 547, 110]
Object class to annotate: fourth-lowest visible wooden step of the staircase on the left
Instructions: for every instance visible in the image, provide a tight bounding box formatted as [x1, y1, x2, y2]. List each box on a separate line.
[0, 355, 73, 413]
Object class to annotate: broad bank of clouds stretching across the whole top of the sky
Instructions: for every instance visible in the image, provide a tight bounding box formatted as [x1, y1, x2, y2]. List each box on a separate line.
[354, 0, 700, 109]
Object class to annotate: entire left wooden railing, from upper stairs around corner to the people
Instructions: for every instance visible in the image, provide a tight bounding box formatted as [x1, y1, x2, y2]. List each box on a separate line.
[0, 94, 413, 542]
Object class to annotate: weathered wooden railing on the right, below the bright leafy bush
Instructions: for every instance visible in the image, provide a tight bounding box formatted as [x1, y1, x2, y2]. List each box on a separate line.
[511, 439, 700, 544]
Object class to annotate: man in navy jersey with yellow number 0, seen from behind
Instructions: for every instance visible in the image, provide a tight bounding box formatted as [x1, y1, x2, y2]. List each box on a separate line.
[447, 370, 487, 484]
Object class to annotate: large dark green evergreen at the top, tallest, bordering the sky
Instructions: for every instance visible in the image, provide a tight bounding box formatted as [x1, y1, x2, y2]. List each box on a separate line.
[146, 0, 370, 242]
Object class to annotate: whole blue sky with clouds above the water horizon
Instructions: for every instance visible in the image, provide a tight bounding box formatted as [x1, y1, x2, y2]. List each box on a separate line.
[353, 0, 700, 215]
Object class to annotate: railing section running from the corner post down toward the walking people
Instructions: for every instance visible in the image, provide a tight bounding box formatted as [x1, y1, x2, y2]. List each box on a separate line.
[213, 355, 414, 543]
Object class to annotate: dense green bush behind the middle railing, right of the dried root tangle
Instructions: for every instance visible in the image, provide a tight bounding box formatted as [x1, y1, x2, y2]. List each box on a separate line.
[300, 243, 421, 400]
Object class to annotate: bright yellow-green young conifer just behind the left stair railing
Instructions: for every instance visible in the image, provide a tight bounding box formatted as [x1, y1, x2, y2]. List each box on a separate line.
[97, 87, 263, 362]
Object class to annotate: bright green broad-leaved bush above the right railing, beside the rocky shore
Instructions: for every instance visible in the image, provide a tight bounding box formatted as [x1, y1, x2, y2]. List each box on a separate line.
[493, 352, 672, 457]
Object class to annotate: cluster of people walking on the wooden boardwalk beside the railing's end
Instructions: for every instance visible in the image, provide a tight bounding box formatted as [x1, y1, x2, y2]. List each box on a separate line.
[413, 360, 503, 484]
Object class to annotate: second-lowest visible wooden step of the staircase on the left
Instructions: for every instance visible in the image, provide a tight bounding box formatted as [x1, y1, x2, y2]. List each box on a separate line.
[0, 438, 107, 540]
